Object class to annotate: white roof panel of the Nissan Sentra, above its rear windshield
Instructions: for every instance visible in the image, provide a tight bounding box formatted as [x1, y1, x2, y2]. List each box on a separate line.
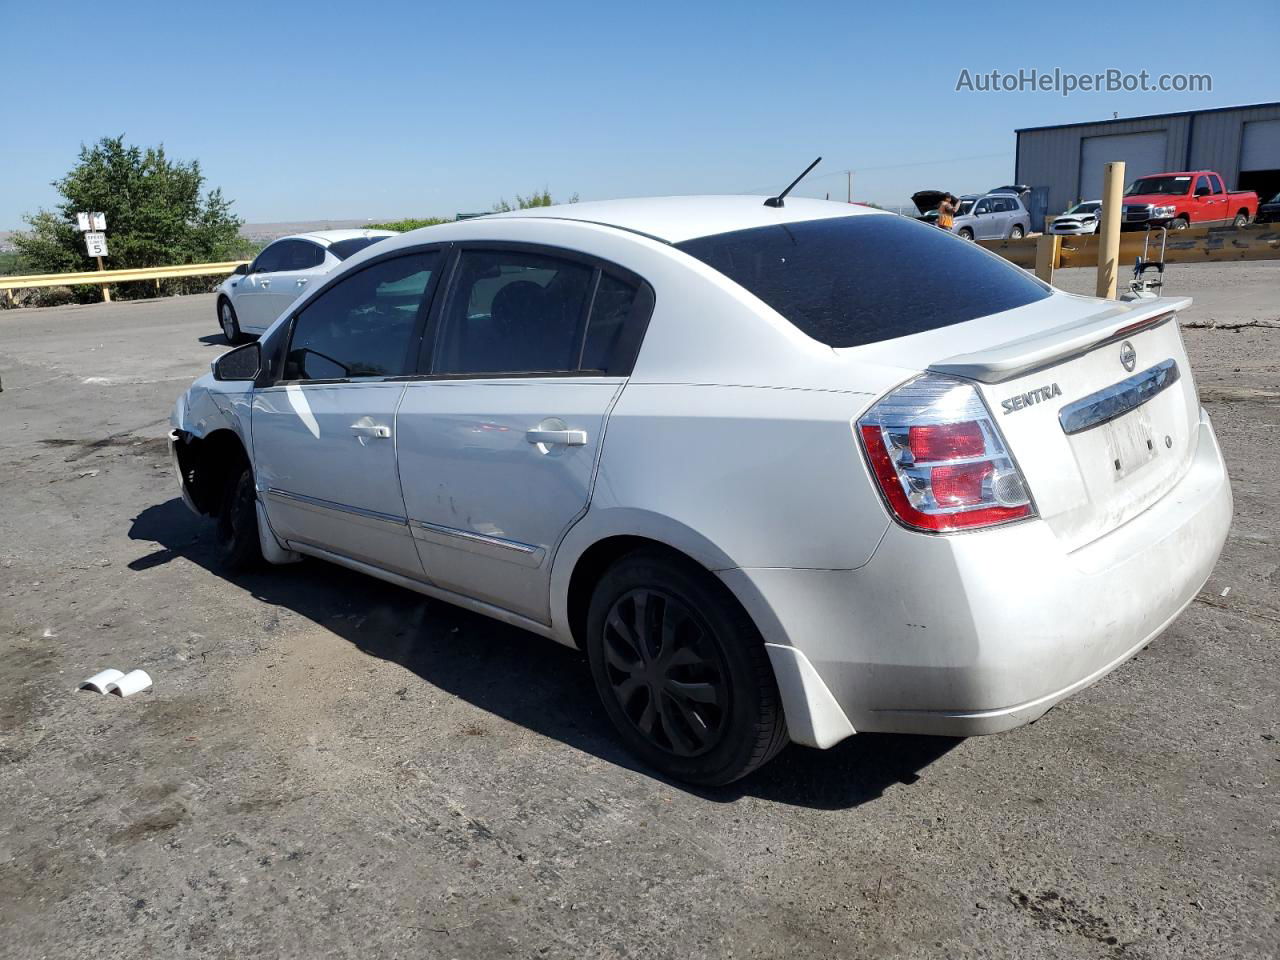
[481, 196, 887, 243]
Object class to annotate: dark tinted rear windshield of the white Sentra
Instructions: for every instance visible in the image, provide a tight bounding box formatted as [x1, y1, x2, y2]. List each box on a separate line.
[676, 214, 1050, 347]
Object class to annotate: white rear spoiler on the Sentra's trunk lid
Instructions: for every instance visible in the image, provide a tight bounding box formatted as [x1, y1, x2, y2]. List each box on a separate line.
[929, 297, 1192, 383]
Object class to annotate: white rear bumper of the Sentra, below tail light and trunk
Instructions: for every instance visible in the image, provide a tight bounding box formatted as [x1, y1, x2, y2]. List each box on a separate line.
[722, 411, 1231, 746]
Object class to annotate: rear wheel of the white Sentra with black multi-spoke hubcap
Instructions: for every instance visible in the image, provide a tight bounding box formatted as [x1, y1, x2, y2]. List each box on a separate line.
[586, 550, 788, 786]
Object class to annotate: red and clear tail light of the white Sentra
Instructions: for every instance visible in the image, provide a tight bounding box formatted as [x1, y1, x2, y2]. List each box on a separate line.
[858, 374, 1036, 532]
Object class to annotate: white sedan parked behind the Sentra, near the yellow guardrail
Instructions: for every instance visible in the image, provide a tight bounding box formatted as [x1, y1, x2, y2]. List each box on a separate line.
[218, 230, 396, 343]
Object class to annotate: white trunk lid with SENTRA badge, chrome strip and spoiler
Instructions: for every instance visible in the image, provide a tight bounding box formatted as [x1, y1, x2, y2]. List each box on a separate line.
[852, 293, 1199, 550]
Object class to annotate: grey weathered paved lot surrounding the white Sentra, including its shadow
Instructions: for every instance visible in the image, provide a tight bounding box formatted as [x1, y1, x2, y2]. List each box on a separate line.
[0, 262, 1280, 960]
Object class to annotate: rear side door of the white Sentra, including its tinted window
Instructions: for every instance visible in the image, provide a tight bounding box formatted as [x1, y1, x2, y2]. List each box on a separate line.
[396, 244, 653, 623]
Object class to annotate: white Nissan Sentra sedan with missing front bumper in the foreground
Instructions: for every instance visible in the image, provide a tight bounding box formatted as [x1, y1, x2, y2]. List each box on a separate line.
[172, 197, 1231, 783]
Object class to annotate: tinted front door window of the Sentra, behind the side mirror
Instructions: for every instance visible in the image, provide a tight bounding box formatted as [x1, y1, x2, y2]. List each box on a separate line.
[284, 252, 439, 380]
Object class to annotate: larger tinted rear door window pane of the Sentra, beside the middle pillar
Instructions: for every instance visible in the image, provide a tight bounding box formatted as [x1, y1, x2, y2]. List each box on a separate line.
[433, 251, 593, 374]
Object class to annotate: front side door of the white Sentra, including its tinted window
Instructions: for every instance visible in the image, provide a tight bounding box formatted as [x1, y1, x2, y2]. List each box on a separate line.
[252, 250, 442, 579]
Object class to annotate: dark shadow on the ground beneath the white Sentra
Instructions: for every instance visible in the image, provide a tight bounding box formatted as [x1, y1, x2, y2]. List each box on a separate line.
[128, 498, 960, 809]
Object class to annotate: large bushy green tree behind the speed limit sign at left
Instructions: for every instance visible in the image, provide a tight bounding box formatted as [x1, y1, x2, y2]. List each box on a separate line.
[13, 136, 247, 301]
